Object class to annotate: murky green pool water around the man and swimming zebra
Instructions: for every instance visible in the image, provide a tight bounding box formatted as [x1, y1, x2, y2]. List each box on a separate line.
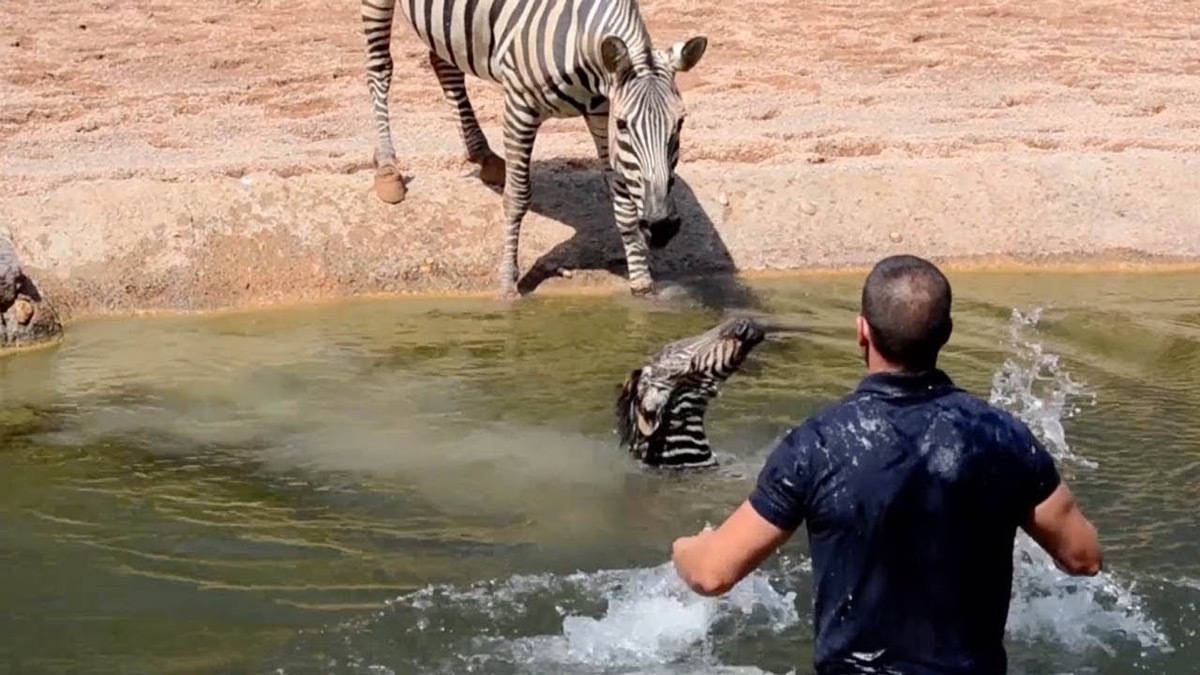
[0, 274, 1200, 675]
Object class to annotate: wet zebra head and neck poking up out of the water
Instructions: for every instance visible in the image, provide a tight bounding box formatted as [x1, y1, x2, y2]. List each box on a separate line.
[616, 318, 766, 467]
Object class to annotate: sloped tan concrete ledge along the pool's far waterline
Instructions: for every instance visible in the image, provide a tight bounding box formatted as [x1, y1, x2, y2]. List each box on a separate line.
[0, 151, 1200, 319]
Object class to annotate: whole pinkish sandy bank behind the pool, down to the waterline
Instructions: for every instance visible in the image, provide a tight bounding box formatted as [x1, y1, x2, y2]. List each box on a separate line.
[0, 0, 1200, 317]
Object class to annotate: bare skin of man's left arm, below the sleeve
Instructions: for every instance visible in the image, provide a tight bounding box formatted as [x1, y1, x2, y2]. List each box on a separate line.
[671, 501, 792, 596]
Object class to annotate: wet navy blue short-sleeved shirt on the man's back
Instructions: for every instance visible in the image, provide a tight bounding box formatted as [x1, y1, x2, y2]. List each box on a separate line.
[750, 370, 1060, 675]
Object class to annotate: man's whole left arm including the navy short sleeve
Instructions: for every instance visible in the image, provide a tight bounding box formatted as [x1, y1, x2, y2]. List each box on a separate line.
[671, 425, 809, 596]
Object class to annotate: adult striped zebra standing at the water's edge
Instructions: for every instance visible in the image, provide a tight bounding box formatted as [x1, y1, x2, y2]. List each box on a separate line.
[362, 0, 708, 297]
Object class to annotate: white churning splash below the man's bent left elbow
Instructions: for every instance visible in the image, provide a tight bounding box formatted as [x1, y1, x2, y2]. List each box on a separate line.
[286, 563, 799, 675]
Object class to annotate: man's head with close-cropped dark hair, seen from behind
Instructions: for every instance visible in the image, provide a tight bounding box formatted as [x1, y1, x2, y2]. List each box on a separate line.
[857, 255, 953, 372]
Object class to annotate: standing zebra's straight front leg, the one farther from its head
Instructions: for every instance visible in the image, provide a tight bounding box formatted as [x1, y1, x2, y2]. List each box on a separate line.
[500, 93, 545, 299]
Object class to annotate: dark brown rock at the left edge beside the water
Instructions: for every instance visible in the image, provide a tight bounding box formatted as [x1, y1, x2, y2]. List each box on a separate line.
[0, 227, 62, 353]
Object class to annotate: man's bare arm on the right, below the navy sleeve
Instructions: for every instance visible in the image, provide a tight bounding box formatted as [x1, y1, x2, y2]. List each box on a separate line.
[1022, 483, 1104, 577]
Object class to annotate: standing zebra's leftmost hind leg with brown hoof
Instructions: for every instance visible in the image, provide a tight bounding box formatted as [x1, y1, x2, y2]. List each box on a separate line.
[362, 0, 408, 204]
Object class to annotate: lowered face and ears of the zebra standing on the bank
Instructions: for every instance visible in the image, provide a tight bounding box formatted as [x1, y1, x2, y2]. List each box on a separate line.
[600, 35, 708, 249]
